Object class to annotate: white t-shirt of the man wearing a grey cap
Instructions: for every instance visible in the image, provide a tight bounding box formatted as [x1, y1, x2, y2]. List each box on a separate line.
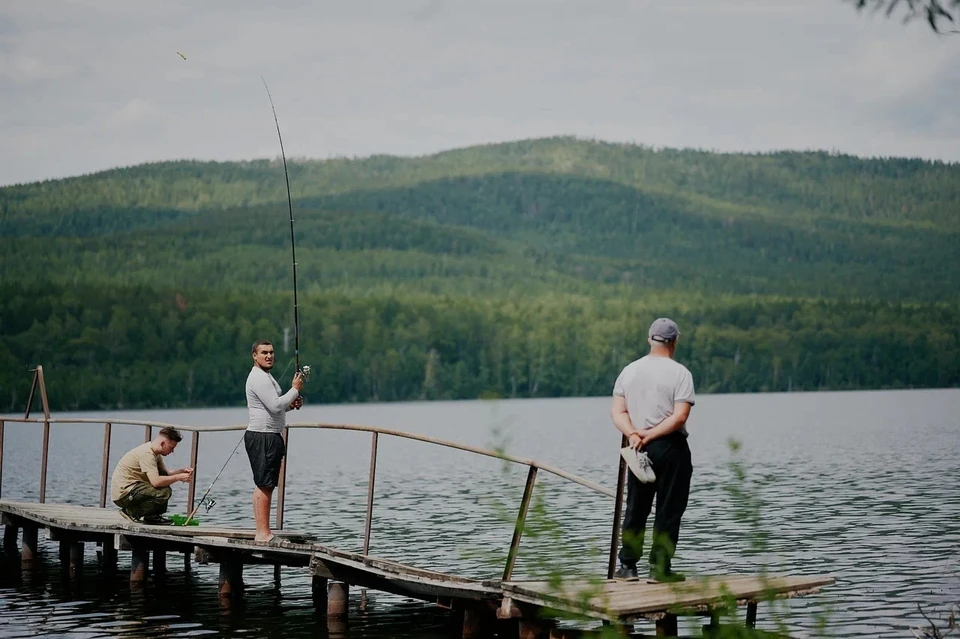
[613, 355, 696, 436]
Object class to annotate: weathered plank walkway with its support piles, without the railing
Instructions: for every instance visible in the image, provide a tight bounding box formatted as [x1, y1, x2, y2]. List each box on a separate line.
[0, 501, 834, 638]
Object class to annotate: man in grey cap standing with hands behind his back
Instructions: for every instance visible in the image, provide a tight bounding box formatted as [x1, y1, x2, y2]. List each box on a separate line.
[611, 317, 695, 582]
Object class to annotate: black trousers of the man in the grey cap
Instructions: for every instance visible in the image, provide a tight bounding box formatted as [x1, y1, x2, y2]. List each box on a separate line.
[620, 432, 693, 570]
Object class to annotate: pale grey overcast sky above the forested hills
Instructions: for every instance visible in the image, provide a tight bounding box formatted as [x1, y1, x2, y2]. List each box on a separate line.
[0, 0, 960, 184]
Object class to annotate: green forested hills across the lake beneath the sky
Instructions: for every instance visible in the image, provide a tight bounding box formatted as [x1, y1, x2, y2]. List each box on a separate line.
[0, 138, 960, 410]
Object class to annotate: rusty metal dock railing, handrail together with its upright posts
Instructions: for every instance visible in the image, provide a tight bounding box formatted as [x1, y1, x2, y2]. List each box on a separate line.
[0, 366, 624, 581]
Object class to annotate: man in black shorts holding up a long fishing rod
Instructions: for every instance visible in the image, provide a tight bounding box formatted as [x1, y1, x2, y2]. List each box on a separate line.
[243, 340, 303, 541]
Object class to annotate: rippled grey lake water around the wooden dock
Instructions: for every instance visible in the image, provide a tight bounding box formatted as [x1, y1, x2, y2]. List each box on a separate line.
[0, 389, 960, 639]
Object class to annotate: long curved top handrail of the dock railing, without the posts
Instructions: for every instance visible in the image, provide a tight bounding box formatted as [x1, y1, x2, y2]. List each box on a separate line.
[0, 416, 616, 497]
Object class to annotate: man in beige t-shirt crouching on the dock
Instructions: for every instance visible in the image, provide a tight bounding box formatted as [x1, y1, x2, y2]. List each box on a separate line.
[110, 427, 193, 525]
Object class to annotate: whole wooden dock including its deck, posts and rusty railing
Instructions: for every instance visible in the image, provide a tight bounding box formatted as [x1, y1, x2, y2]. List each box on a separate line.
[0, 378, 834, 639]
